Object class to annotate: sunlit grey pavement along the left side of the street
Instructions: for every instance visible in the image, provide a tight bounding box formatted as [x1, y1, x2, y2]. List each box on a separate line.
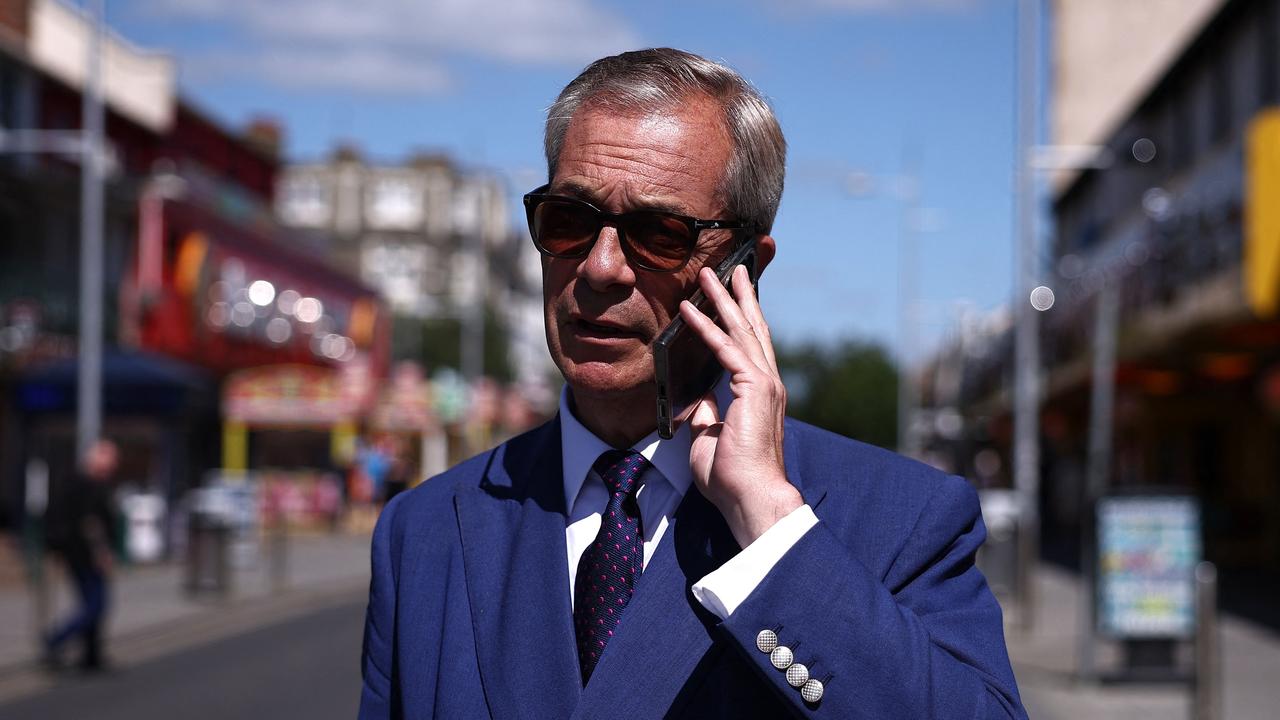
[0, 532, 370, 702]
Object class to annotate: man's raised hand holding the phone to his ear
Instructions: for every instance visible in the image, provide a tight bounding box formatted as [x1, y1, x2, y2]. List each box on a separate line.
[680, 260, 804, 547]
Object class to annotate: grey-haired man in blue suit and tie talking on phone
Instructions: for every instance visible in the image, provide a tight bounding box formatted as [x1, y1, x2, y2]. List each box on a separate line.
[361, 50, 1024, 719]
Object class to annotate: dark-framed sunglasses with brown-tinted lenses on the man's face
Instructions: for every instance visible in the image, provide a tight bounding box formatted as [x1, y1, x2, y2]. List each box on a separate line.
[525, 184, 754, 273]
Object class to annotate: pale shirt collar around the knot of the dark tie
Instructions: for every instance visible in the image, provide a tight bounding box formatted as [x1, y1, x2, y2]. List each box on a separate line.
[559, 374, 733, 511]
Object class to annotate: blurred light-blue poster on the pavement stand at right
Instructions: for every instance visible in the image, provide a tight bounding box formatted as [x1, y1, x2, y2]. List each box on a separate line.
[1097, 495, 1201, 639]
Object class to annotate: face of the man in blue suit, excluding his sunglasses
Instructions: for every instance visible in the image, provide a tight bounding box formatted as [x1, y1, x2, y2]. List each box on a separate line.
[543, 99, 732, 411]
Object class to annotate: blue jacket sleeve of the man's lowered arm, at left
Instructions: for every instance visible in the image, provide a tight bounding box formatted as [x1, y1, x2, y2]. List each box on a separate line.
[360, 497, 401, 720]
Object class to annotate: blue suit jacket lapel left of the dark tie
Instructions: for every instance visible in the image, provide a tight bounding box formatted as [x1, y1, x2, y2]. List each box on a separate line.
[454, 419, 581, 717]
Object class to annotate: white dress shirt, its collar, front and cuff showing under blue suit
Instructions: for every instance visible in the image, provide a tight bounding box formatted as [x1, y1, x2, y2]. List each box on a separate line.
[559, 380, 818, 620]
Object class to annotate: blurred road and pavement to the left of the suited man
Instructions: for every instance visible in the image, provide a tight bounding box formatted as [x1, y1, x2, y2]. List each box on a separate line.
[0, 533, 369, 717]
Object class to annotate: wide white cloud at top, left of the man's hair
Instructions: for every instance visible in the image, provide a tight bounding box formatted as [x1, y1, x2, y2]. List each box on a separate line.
[141, 0, 640, 94]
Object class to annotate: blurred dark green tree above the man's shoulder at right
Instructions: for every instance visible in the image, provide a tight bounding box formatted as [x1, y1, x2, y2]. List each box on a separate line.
[777, 341, 897, 447]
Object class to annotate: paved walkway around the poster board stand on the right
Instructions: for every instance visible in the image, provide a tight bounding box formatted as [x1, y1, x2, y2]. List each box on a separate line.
[1005, 565, 1280, 720]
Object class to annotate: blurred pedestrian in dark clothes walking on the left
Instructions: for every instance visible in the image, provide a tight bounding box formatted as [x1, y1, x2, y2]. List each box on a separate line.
[44, 439, 119, 671]
